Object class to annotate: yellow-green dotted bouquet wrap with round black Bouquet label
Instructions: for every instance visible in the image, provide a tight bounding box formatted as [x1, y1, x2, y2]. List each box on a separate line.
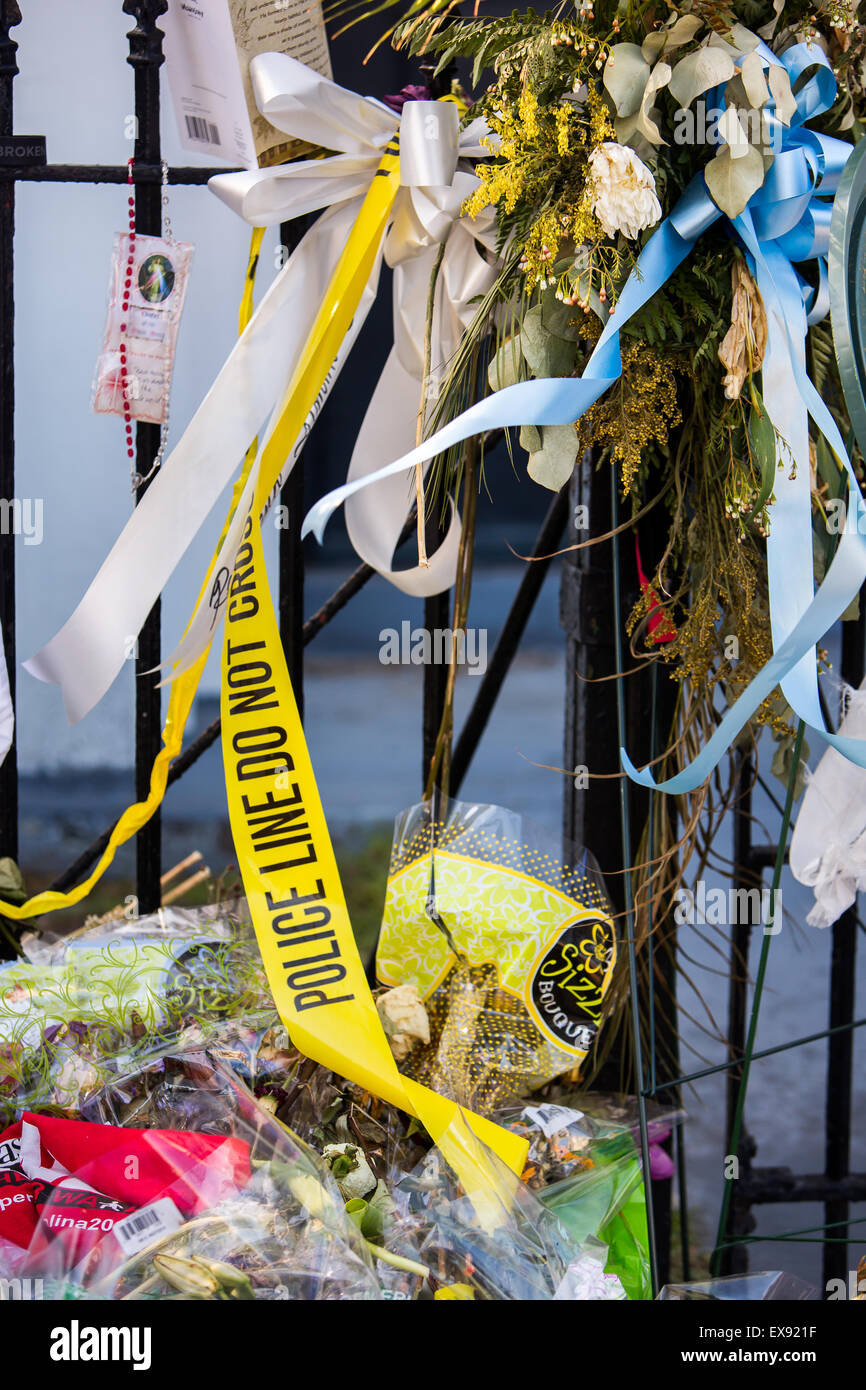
[377, 802, 617, 1113]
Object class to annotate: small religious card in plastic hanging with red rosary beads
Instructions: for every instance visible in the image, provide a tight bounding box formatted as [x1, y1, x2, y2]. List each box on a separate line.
[92, 232, 193, 425]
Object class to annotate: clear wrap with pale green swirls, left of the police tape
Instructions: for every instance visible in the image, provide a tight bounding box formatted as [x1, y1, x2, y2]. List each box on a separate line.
[0, 904, 272, 1120]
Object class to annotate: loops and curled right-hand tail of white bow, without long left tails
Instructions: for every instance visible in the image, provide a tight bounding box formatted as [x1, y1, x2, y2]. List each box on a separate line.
[210, 53, 496, 598]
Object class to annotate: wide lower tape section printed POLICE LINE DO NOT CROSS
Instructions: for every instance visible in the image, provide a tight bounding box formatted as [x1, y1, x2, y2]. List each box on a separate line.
[221, 475, 527, 1184]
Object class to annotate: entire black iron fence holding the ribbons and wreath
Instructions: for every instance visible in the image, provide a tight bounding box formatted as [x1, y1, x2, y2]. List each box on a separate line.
[0, 0, 866, 1282]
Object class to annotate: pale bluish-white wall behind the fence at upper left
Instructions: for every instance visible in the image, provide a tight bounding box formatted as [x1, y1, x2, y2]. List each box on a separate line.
[11, 0, 278, 773]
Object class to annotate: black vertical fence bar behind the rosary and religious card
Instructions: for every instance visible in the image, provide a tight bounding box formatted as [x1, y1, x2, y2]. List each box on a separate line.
[124, 0, 168, 913]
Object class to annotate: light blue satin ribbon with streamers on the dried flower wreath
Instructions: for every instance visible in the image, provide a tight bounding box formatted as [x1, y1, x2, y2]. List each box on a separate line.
[303, 44, 866, 794]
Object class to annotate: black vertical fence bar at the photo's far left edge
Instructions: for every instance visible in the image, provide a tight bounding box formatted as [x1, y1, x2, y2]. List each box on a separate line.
[0, 0, 21, 889]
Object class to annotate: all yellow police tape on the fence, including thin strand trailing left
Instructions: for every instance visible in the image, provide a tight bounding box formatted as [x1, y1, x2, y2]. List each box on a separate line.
[3, 138, 527, 1184]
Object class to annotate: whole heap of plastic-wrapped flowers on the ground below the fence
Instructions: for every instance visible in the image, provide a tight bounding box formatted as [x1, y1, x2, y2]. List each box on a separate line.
[0, 904, 669, 1300]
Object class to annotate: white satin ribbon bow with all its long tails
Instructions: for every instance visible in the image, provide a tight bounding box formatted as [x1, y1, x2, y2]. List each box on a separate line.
[25, 54, 495, 723]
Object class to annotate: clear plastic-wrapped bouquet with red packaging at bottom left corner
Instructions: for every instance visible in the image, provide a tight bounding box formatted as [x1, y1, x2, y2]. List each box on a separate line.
[0, 1052, 379, 1301]
